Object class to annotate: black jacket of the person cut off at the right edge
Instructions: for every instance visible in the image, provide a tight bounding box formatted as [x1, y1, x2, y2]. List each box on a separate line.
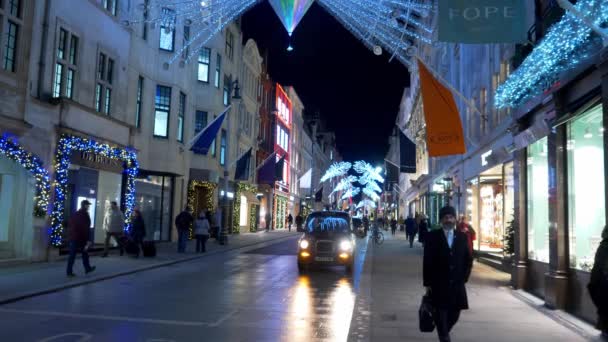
[587, 239, 608, 316]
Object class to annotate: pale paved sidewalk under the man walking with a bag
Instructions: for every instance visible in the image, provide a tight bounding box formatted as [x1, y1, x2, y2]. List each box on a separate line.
[349, 232, 599, 342]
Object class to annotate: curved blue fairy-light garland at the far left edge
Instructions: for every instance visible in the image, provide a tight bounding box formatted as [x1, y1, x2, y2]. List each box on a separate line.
[0, 134, 51, 217]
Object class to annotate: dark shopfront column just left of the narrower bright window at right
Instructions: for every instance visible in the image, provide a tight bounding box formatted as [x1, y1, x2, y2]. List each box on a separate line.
[511, 149, 528, 289]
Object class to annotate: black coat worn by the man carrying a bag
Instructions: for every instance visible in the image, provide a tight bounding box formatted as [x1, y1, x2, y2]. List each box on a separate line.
[423, 229, 473, 310]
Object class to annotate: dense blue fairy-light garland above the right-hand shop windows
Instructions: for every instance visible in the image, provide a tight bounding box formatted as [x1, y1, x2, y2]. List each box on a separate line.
[494, 0, 608, 108]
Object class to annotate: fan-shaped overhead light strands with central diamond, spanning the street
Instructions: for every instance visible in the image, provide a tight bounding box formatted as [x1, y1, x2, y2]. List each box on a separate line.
[123, 0, 434, 68]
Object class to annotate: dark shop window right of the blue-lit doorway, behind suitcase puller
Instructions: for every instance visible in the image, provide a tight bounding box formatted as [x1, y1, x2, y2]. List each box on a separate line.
[135, 171, 175, 241]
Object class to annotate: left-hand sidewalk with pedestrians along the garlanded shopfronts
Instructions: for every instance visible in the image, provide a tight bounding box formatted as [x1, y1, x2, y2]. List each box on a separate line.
[0, 231, 299, 304]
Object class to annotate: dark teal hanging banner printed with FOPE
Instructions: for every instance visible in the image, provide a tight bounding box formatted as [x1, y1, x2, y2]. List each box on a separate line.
[438, 0, 533, 44]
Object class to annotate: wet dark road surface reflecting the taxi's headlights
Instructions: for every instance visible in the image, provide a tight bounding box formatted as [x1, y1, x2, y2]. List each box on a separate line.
[0, 238, 366, 342]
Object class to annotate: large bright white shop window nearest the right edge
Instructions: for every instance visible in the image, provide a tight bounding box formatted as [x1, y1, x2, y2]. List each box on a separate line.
[566, 105, 606, 271]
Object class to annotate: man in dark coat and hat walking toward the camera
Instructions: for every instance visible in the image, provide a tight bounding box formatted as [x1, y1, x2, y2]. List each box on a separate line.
[423, 206, 473, 342]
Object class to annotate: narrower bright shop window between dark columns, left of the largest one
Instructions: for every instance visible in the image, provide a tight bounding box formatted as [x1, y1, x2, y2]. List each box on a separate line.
[526, 137, 549, 262]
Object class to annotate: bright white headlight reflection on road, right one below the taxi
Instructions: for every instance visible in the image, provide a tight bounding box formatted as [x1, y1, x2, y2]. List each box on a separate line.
[329, 278, 355, 341]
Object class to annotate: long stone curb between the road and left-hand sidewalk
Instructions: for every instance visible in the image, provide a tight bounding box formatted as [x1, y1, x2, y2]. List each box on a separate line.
[0, 234, 298, 305]
